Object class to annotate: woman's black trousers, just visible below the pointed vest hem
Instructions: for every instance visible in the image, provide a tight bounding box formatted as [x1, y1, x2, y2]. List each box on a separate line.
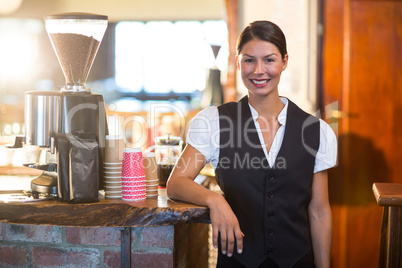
[216, 251, 315, 268]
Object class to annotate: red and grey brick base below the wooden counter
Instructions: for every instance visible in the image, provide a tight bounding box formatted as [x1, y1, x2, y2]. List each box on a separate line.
[0, 223, 175, 268]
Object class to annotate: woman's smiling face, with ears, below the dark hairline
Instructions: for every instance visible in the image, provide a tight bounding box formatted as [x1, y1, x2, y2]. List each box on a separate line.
[236, 39, 288, 96]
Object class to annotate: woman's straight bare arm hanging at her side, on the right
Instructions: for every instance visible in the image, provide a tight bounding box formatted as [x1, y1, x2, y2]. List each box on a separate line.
[308, 170, 332, 268]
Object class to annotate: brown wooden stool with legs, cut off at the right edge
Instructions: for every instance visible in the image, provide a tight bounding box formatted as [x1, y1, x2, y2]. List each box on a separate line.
[373, 183, 402, 268]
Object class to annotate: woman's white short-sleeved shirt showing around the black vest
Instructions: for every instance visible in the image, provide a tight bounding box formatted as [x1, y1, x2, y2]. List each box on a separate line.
[186, 98, 338, 173]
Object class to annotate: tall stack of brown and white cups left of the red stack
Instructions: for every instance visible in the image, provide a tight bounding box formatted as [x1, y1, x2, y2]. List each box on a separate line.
[103, 136, 124, 199]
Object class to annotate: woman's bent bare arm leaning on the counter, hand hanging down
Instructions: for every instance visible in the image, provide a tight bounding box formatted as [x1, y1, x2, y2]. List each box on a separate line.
[166, 145, 243, 257]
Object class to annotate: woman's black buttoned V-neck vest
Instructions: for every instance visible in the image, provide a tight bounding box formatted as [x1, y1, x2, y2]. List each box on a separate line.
[215, 96, 320, 267]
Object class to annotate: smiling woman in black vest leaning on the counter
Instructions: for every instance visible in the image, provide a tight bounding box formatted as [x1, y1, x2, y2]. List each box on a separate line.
[167, 21, 337, 268]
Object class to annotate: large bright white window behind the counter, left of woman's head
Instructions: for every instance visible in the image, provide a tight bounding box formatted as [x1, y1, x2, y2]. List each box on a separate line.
[115, 21, 228, 93]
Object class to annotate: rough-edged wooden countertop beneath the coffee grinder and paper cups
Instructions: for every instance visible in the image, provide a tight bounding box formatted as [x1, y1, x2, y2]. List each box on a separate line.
[0, 189, 210, 227]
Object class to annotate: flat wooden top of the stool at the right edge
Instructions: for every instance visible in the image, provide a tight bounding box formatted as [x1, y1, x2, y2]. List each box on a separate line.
[373, 183, 402, 206]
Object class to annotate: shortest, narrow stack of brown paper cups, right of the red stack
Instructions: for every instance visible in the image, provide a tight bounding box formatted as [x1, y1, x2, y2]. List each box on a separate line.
[143, 153, 159, 198]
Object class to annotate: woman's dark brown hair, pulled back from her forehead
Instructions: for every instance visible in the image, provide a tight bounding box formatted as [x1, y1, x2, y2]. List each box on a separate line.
[236, 20, 288, 58]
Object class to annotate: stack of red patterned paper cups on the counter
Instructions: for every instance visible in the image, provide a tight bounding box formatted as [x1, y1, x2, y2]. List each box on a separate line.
[121, 148, 146, 201]
